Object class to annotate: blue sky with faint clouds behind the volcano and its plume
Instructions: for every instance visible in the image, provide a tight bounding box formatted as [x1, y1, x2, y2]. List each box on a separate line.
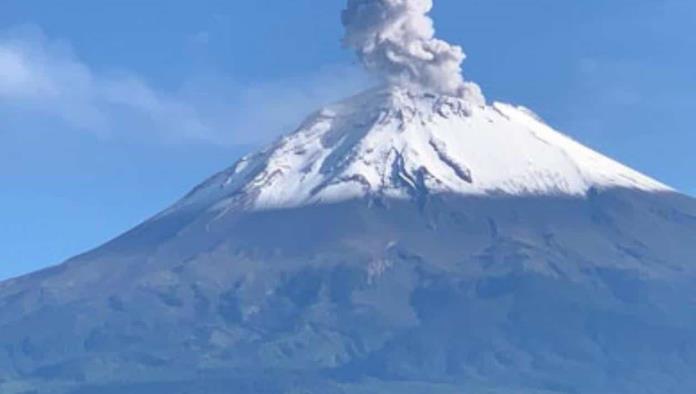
[0, 0, 696, 278]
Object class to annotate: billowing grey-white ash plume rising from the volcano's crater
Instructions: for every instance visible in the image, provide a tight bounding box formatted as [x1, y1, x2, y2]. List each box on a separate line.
[342, 0, 483, 101]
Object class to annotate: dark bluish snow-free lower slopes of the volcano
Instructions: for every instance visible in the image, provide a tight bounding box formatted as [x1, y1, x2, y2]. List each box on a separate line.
[0, 190, 696, 393]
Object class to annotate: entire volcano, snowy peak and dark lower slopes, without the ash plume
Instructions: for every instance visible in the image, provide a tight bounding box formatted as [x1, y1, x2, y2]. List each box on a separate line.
[0, 88, 696, 394]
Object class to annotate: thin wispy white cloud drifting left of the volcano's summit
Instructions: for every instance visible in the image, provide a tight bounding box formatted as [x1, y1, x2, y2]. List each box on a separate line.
[0, 27, 367, 145]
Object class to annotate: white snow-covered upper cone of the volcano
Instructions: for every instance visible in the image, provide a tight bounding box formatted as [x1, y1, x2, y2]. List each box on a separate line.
[178, 87, 671, 209]
